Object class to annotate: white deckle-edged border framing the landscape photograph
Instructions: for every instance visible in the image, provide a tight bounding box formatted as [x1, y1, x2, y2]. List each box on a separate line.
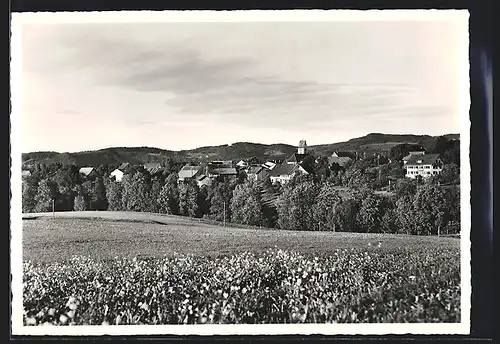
[10, 10, 471, 336]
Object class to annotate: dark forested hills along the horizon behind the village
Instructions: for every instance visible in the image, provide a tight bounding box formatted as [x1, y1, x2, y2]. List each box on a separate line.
[22, 133, 460, 166]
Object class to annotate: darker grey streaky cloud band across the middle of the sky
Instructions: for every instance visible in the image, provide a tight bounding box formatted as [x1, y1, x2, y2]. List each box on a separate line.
[51, 41, 430, 127]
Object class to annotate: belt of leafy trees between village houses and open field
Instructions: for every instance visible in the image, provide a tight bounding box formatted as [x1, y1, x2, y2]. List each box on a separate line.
[22, 152, 460, 235]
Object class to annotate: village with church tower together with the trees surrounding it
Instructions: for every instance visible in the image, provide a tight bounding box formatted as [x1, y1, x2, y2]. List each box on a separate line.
[23, 135, 459, 234]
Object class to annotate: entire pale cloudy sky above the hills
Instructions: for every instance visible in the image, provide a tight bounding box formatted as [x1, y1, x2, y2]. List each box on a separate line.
[15, 12, 468, 152]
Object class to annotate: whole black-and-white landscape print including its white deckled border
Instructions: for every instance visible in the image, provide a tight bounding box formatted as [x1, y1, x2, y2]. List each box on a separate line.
[10, 10, 471, 335]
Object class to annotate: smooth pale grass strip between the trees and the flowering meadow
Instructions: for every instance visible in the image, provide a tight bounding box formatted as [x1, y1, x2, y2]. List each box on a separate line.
[23, 212, 460, 262]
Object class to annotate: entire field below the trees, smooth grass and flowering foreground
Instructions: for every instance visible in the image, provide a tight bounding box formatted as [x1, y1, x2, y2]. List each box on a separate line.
[23, 214, 460, 325]
